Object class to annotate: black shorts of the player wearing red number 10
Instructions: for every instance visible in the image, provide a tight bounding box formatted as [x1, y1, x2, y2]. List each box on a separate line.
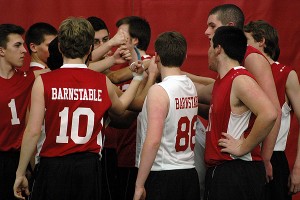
[30, 152, 101, 200]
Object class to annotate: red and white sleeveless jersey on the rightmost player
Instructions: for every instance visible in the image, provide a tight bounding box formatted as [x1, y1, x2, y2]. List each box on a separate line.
[271, 62, 293, 151]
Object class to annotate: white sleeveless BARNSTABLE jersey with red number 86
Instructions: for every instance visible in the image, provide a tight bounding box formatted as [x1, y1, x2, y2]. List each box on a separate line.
[136, 75, 198, 171]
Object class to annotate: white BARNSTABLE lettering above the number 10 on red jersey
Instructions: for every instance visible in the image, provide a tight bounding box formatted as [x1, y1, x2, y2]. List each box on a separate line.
[51, 88, 102, 101]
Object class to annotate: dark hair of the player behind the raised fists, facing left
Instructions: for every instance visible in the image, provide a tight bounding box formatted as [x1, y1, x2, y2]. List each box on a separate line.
[116, 16, 151, 51]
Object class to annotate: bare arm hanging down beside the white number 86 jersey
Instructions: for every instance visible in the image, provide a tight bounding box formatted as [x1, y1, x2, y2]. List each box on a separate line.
[134, 85, 169, 200]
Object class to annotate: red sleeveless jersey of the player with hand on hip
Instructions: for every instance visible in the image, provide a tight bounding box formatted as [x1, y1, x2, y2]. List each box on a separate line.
[205, 67, 261, 166]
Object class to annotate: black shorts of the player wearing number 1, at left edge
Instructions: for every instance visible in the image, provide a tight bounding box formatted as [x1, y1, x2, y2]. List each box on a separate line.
[0, 151, 20, 200]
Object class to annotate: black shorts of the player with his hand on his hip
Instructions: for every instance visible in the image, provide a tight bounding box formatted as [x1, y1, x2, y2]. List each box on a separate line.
[204, 159, 266, 200]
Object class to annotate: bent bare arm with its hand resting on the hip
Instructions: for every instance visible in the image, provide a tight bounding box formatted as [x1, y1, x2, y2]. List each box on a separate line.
[219, 75, 277, 156]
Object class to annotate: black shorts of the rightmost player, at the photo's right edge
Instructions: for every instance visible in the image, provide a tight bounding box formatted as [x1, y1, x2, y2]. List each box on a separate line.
[265, 151, 292, 200]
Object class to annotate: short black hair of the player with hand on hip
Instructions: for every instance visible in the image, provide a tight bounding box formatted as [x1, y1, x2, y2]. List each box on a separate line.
[212, 26, 247, 63]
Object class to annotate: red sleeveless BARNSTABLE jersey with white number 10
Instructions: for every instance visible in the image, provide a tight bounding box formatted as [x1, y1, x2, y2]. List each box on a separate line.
[38, 64, 111, 157]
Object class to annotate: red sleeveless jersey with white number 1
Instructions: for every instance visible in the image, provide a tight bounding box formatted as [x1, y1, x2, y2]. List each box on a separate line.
[0, 70, 35, 151]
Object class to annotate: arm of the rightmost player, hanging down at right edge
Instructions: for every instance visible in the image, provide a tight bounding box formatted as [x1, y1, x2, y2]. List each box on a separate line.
[286, 71, 300, 194]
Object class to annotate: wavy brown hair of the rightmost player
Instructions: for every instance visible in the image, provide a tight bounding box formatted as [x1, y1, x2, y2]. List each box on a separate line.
[244, 20, 280, 61]
